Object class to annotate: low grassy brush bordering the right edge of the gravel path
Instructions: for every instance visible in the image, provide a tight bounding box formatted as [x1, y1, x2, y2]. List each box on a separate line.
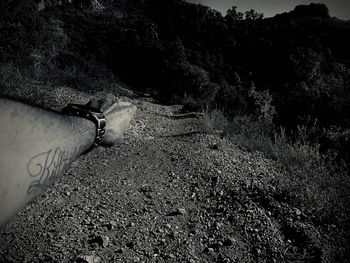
[226, 116, 350, 227]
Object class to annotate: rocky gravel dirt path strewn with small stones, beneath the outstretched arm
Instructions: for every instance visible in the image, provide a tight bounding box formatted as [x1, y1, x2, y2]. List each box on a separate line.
[0, 85, 334, 263]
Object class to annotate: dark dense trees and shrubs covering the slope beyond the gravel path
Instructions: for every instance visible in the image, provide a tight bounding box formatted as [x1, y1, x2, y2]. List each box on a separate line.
[0, 0, 350, 260]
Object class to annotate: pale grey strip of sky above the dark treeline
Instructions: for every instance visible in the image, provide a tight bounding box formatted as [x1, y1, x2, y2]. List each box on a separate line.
[187, 0, 350, 19]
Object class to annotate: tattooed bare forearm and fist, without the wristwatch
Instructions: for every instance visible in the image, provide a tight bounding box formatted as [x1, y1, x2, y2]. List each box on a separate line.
[0, 98, 136, 225]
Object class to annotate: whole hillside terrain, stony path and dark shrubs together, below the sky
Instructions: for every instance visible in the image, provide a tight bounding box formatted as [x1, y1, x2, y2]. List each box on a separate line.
[0, 0, 350, 263]
